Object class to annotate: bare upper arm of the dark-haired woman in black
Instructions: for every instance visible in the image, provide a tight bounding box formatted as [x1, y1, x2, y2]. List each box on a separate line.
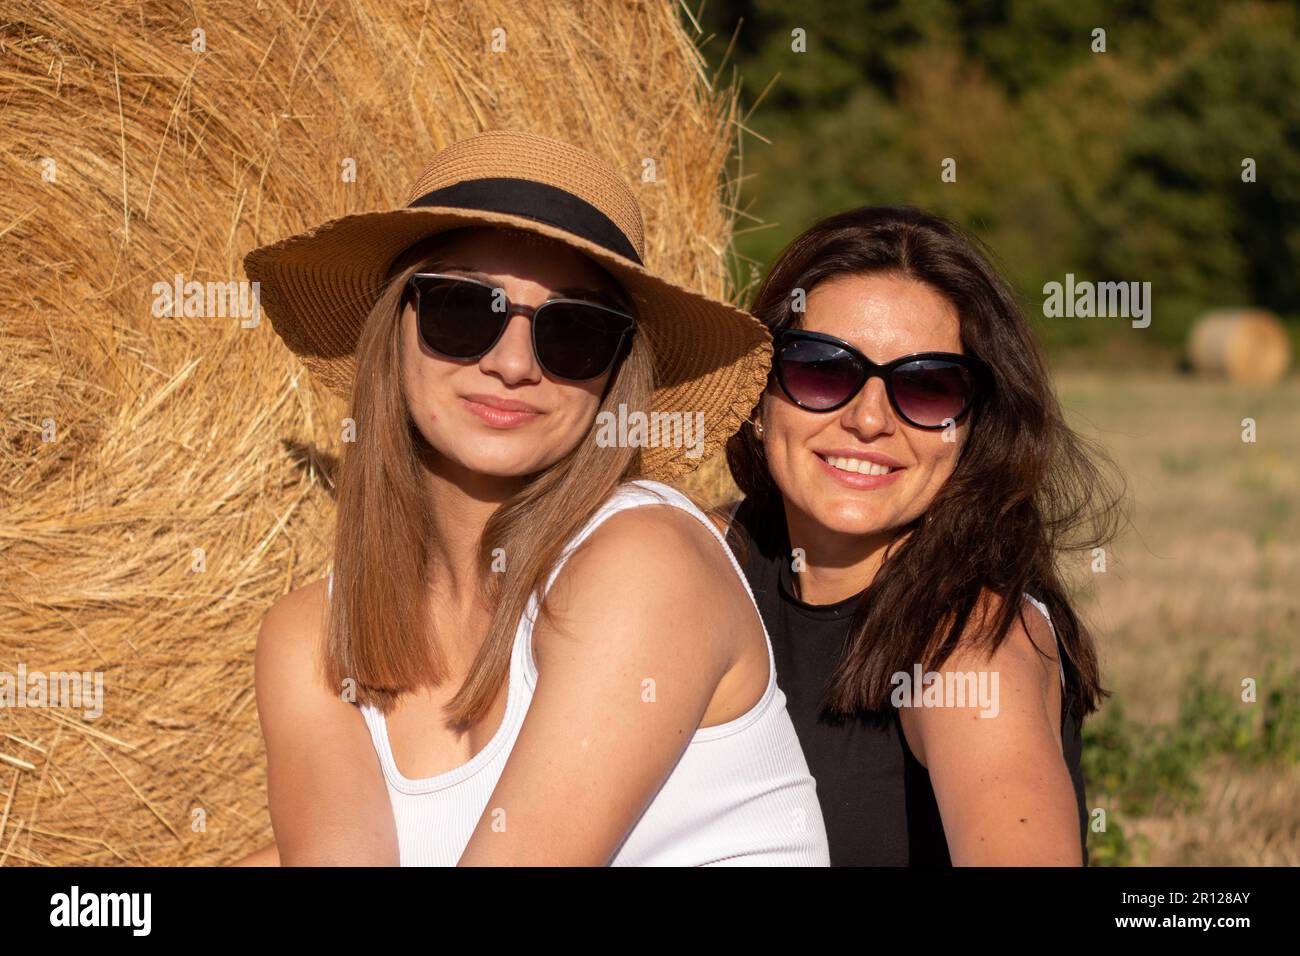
[913, 598, 1083, 866]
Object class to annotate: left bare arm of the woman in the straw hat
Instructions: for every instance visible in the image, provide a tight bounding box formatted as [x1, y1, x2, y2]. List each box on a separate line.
[255, 583, 398, 866]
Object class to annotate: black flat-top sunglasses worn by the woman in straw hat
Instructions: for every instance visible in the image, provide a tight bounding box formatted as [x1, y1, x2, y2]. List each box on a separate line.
[407, 272, 636, 381]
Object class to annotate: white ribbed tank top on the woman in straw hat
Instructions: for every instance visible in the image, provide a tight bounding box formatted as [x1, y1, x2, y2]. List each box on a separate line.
[340, 480, 831, 866]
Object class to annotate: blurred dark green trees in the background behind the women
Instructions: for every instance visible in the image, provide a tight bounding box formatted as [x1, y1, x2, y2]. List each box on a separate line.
[699, 0, 1300, 356]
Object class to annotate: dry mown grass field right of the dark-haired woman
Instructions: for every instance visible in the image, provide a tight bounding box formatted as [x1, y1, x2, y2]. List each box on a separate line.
[693, 372, 1300, 865]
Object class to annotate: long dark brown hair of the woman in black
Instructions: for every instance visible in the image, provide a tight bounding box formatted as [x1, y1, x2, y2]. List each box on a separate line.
[727, 207, 1123, 719]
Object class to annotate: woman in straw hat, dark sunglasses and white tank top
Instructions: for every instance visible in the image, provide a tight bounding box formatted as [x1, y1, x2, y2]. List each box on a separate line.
[246, 131, 828, 865]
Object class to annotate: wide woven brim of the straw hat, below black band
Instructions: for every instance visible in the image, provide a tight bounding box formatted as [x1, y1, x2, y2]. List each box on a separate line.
[244, 206, 772, 481]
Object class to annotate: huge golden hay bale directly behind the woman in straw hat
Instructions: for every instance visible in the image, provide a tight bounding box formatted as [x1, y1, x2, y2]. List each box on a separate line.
[0, 0, 735, 865]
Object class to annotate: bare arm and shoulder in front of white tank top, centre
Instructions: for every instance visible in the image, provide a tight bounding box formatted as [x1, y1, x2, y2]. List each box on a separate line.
[460, 506, 763, 866]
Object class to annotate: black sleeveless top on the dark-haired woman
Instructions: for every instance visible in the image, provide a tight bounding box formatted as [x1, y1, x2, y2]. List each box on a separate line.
[728, 496, 1088, 866]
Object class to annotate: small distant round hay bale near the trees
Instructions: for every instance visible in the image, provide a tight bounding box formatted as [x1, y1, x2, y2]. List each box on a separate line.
[1187, 308, 1291, 385]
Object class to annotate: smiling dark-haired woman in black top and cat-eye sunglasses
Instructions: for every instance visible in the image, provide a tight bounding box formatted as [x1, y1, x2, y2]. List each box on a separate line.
[727, 207, 1119, 865]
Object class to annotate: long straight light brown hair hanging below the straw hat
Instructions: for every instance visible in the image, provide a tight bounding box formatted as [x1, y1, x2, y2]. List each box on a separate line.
[324, 237, 654, 724]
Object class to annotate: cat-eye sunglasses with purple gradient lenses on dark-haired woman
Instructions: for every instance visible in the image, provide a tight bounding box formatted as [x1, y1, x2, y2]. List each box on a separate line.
[772, 329, 993, 431]
